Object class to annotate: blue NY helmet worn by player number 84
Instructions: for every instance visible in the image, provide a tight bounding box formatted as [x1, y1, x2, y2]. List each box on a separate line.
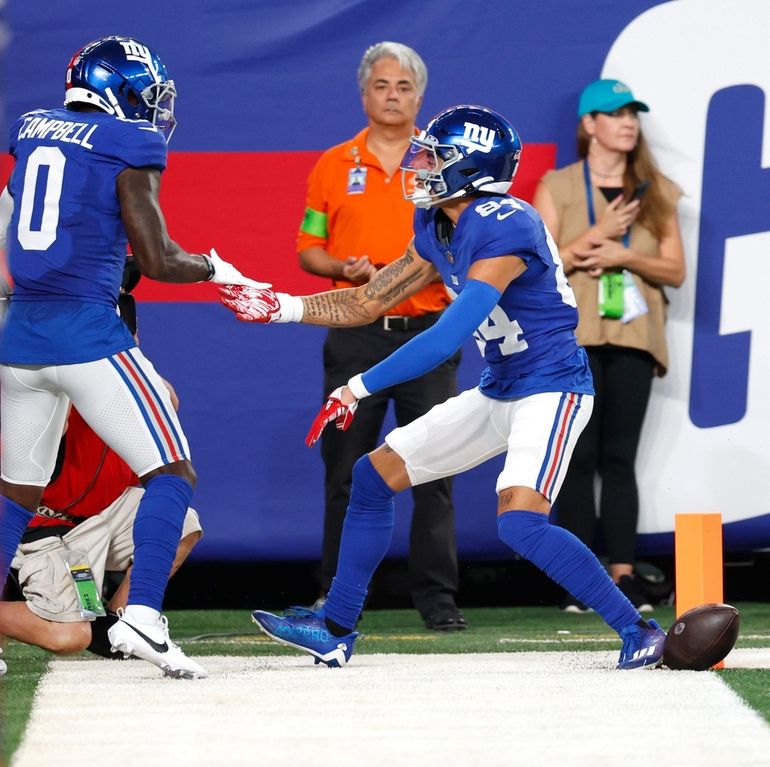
[401, 104, 521, 208]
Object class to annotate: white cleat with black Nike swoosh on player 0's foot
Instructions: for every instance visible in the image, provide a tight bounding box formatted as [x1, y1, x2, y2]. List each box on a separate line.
[107, 610, 208, 679]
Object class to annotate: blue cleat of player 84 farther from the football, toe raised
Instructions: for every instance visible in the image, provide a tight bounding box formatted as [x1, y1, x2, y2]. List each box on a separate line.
[251, 607, 358, 668]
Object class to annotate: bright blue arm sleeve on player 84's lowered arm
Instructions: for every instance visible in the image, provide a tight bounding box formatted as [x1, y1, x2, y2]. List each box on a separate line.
[362, 280, 500, 393]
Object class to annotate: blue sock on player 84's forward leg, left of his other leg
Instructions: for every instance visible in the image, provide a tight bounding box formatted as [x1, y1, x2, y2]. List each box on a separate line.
[324, 455, 395, 629]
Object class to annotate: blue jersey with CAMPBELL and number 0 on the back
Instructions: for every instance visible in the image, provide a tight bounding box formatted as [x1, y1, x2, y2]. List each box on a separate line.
[0, 108, 167, 364]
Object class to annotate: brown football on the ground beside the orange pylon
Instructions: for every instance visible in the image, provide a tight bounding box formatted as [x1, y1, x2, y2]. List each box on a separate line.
[663, 603, 741, 671]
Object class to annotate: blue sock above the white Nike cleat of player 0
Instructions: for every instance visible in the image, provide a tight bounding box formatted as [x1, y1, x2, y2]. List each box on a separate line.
[128, 474, 193, 612]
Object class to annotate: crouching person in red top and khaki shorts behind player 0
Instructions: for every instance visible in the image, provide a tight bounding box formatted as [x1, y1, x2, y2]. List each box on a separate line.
[0, 404, 202, 657]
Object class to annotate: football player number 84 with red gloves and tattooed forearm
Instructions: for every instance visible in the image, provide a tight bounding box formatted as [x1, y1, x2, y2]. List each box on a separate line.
[220, 106, 666, 669]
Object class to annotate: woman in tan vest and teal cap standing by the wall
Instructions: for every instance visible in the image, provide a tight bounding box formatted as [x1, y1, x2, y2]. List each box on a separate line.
[534, 80, 685, 612]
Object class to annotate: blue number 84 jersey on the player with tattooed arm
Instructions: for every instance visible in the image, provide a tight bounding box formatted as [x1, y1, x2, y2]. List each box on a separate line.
[414, 195, 593, 399]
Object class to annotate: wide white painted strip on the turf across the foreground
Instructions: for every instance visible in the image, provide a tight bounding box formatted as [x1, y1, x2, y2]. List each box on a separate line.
[11, 650, 770, 767]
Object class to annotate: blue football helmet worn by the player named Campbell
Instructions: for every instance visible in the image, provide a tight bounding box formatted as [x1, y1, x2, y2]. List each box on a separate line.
[64, 36, 176, 141]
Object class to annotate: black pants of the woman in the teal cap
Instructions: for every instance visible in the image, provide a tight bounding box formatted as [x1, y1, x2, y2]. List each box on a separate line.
[556, 345, 655, 564]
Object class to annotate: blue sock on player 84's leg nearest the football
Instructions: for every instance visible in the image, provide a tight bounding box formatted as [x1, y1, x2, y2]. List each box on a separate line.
[497, 511, 642, 632]
